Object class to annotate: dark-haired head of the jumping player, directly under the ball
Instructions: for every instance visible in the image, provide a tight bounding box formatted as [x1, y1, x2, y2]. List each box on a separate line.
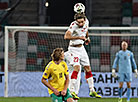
[74, 13, 86, 27]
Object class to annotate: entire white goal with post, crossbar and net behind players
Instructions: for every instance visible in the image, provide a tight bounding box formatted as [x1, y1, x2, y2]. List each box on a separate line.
[5, 26, 138, 97]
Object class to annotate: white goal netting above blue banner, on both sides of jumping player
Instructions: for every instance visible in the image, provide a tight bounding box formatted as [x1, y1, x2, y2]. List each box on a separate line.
[6, 28, 138, 72]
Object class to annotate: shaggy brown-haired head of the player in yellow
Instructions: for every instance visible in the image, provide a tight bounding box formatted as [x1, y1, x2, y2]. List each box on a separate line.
[51, 48, 64, 61]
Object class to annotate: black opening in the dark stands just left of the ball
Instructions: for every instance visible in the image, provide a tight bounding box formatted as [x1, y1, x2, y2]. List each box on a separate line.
[46, 0, 85, 25]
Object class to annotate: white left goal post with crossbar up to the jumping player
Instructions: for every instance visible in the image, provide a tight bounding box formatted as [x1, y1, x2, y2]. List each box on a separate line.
[4, 26, 67, 97]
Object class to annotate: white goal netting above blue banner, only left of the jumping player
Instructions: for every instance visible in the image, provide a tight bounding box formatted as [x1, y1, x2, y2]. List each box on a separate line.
[8, 30, 68, 72]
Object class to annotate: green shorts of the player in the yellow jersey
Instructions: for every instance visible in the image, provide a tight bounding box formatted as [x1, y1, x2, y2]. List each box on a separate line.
[50, 89, 72, 102]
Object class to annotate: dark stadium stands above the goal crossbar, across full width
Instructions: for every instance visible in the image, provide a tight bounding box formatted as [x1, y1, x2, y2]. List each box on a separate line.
[0, 0, 138, 26]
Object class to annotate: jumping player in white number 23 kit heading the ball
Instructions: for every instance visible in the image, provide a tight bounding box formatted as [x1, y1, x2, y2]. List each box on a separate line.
[64, 12, 101, 99]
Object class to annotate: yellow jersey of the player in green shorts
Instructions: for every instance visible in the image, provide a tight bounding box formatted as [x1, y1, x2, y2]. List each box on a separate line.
[43, 61, 69, 95]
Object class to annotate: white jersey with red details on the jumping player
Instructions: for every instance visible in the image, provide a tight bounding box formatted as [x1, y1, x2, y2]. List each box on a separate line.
[68, 19, 89, 45]
